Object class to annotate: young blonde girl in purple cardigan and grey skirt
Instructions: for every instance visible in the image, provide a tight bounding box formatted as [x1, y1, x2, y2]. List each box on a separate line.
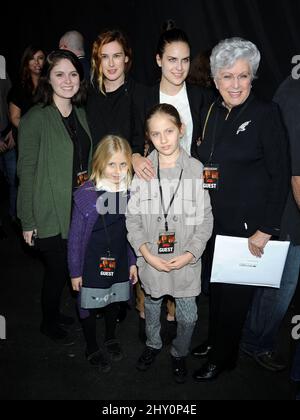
[68, 135, 137, 372]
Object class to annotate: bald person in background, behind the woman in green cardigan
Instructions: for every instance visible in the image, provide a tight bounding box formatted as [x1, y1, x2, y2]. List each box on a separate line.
[58, 31, 91, 82]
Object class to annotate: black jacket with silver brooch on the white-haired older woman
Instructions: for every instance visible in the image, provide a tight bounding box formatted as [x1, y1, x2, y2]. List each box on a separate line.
[197, 95, 289, 237]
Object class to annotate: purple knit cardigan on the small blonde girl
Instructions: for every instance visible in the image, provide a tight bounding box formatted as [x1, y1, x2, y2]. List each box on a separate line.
[68, 181, 136, 278]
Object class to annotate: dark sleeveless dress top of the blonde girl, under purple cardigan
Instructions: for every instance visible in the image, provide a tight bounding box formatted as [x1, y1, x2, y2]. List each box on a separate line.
[83, 191, 129, 289]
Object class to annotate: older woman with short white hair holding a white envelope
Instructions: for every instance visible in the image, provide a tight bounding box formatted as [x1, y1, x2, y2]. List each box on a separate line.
[192, 38, 289, 381]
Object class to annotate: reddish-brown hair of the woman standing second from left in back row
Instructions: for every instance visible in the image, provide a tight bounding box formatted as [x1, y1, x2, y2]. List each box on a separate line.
[91, 29, 132, 94]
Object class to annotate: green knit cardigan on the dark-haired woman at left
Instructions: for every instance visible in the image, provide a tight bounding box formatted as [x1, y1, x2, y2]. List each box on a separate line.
[18, 105, 92, 239]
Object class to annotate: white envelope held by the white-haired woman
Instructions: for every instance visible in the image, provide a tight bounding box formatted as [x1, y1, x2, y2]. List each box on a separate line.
[211, 235, 290, 289]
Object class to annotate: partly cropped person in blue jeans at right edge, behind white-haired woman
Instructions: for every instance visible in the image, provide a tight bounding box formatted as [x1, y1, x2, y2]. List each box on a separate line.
[241, 76, 300, 372]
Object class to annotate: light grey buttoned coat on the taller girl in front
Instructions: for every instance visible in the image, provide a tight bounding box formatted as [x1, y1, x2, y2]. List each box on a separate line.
[126, 149, 213, 298]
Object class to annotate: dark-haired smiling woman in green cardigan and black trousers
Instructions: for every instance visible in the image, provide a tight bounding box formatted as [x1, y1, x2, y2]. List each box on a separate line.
[18, 50, 92, 340]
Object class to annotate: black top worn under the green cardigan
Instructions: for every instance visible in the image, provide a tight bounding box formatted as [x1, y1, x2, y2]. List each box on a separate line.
[63, 110, 91, 188]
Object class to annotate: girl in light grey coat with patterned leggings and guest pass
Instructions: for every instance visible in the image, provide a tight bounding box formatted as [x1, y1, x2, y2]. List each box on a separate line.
[126, 104, 213, 383]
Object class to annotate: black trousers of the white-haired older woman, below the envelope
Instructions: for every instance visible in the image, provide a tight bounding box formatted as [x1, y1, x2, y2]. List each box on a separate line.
[209, 283, 256, 367]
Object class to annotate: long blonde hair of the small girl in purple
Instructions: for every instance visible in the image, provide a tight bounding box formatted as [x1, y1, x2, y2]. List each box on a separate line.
[90, 135, 133, 187]
